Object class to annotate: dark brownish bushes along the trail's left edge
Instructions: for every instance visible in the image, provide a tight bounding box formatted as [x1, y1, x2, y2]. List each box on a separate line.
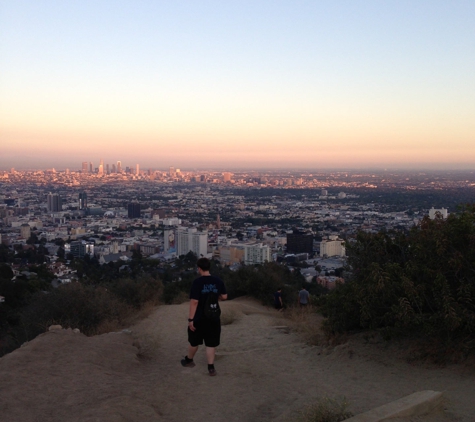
[0, 275, 162, 356]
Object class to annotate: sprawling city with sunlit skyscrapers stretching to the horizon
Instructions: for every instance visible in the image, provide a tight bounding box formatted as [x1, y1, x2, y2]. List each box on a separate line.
[0, 165, 475, 294]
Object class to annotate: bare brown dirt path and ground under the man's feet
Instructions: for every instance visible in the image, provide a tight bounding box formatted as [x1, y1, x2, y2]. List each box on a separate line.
[0, 299, 475, 422]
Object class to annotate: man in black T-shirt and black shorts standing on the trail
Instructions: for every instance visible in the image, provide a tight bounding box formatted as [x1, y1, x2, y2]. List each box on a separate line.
[181, 258, 228, 376]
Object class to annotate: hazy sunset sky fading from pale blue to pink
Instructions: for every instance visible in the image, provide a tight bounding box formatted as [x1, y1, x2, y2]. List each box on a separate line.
[0, 0, 475, 169]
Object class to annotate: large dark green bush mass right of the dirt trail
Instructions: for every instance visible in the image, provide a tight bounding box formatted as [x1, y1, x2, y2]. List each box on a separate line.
[322, 206, 475, 348]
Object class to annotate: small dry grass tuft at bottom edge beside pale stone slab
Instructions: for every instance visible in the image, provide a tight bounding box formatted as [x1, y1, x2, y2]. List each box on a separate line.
[296, 397, 353, 422]
